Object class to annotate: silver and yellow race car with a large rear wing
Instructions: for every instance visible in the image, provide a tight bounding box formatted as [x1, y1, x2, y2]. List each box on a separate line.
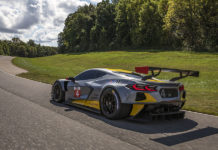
[51, 66, 199, 119]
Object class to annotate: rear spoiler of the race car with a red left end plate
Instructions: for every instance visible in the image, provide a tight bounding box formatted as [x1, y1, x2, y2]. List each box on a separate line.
[135, 66, 199, 81]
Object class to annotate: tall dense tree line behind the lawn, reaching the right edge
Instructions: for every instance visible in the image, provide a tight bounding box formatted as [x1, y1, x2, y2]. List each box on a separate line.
[58, 0, 218, 53]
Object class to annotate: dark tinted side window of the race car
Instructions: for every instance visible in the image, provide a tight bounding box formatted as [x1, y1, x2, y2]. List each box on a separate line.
[75, 70, 106, 80]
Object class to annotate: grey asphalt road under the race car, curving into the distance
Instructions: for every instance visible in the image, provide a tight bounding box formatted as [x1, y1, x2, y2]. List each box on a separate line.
[0, 56, 218, 150]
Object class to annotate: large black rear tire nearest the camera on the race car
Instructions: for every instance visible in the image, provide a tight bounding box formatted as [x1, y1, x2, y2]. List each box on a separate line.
[100, 88, 132, 120]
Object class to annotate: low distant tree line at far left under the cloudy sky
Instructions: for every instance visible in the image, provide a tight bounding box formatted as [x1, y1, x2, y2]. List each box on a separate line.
[0, 38, 58, 57]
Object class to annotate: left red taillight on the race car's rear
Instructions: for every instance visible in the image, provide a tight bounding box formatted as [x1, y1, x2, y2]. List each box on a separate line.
[127, 84, 157, 92]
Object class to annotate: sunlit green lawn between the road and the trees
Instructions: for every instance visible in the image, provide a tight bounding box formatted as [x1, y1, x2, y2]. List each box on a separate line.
[13, 51, 218, 115]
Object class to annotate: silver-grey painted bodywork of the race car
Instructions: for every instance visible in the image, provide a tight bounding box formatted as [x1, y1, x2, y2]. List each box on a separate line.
[58, 68, 184, 104]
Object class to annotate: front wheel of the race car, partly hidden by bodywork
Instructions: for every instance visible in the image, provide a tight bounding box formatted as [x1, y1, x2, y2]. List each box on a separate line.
[52, 81, 65, 103]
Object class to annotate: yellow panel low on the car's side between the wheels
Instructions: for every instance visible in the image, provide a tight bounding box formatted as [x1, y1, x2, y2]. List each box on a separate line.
[72, 100, 100, 110]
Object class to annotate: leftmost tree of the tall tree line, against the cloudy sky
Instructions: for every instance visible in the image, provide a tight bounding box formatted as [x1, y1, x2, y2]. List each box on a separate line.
[58, 4, 95, 52]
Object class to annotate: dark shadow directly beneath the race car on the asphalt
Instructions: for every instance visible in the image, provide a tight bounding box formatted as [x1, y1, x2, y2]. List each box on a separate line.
[50, 101, 198, 134]
